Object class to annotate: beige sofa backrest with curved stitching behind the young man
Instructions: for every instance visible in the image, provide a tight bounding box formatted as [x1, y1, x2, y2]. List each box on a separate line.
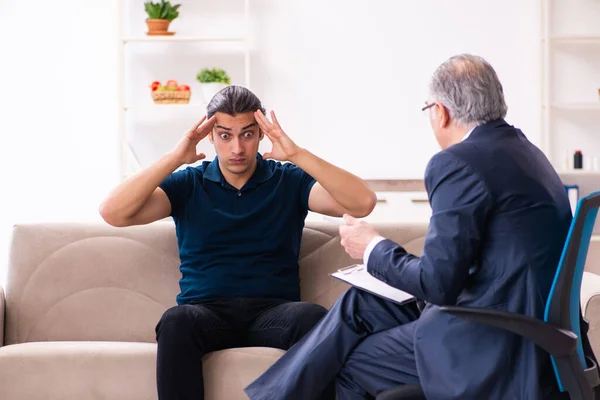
[5, 221, 427, 344]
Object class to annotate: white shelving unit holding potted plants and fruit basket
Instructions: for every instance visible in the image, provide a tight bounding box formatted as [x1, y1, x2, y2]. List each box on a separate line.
[118, 0, 250, 179]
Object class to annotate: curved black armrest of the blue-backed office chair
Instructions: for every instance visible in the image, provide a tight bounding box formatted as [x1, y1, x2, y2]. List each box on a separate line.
[440, 306, 577, 357]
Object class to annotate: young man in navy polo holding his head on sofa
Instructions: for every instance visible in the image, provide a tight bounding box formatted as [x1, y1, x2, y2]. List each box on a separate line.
[100, 86, 376, 400]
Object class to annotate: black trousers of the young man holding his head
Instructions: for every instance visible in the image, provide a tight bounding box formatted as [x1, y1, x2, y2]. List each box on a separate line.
[156, 298, 327, 400]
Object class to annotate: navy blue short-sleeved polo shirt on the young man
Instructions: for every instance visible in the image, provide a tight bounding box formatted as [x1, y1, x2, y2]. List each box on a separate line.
[159, 154, 315, 304]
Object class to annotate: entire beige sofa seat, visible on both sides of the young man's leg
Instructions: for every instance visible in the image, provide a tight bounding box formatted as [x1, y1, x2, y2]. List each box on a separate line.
[0, 342, 284, 400]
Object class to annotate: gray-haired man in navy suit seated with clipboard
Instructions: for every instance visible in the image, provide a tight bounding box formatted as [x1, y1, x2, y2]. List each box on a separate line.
[246, 54, 589, 400]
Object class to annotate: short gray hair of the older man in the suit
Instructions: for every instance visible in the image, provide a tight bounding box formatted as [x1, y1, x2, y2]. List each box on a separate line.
[429, 54, 508, 127]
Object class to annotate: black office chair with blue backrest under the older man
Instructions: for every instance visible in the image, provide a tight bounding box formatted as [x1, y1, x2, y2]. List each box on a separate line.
[377, 191, 600, 400]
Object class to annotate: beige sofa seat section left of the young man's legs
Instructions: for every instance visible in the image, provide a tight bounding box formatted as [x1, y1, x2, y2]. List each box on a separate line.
[0, 342, 157, 400]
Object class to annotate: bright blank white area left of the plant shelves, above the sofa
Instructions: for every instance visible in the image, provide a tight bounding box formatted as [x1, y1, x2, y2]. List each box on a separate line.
[0, 0, 118, 286]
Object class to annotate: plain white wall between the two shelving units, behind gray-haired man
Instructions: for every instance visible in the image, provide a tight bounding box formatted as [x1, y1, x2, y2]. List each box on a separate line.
[252, 0, 540, 179]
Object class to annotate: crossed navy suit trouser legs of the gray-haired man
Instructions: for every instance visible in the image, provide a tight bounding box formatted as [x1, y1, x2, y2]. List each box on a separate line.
[245, 288, 420, 400]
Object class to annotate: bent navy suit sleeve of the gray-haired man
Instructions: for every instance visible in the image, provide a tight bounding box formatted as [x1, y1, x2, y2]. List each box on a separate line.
[367, 152, 492, 305]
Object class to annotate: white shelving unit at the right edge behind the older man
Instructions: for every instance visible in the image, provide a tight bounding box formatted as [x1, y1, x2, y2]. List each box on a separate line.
[540, 0, 600, 175]
